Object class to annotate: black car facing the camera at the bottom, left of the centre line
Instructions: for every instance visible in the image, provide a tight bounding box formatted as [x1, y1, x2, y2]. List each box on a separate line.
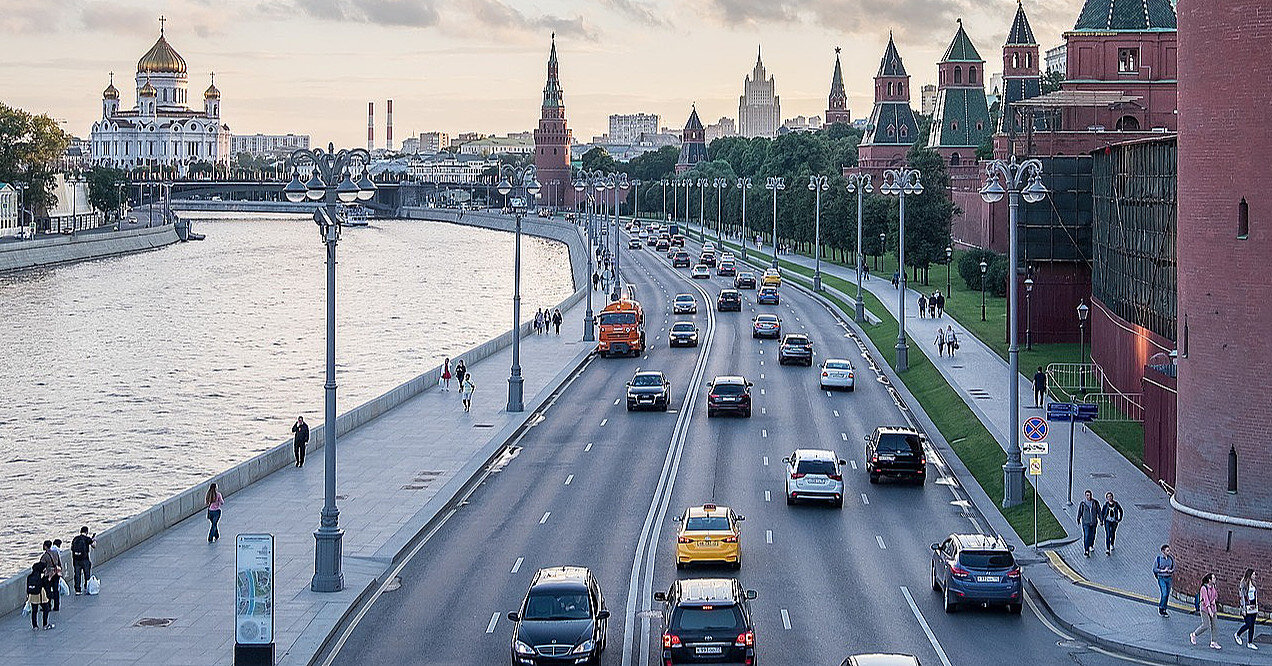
[508, 567, 609, 666]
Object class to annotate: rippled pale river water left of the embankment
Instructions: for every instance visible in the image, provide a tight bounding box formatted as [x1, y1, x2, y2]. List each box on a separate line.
[0, 217, 572, 577]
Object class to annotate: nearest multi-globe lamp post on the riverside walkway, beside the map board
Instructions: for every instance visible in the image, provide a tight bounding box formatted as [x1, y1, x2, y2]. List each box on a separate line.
[290, 144, 375, 592]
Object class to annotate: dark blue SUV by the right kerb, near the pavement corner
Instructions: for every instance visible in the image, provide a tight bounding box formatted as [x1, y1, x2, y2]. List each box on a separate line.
[932, 534, 1024, 615]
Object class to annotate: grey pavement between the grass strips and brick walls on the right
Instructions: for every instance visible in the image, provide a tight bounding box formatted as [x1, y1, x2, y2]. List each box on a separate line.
[695, 225, 1272, 665]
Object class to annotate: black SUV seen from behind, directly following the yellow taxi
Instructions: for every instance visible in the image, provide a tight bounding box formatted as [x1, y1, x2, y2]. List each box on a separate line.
[654, 578, 756, 665]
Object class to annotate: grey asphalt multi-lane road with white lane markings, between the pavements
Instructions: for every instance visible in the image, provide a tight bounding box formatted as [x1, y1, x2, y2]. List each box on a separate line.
[326, 224, 1154, 666]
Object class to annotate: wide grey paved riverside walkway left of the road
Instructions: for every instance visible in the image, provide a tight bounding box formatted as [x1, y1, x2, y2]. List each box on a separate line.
[0, 297, 593, 666]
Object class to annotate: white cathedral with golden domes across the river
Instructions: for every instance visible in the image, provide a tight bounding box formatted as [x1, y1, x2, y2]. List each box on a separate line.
[92, 19, 230, 173]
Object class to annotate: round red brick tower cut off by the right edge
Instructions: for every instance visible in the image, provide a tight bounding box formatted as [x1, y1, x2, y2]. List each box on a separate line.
[1170, 0, 1272, 602]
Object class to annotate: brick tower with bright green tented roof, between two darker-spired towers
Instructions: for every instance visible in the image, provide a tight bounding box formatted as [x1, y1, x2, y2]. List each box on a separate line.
[927, 19, 993, 167]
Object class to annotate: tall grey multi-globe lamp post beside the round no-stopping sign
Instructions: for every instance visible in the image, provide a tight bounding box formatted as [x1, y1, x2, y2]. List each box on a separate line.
[981, 155, 1047, 507]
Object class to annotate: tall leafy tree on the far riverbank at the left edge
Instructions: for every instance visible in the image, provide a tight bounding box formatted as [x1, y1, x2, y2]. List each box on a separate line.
[0, 102, 70, 210]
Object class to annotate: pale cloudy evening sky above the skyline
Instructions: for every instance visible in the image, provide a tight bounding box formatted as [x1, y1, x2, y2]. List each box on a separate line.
[0, 0, 1082, 146]
